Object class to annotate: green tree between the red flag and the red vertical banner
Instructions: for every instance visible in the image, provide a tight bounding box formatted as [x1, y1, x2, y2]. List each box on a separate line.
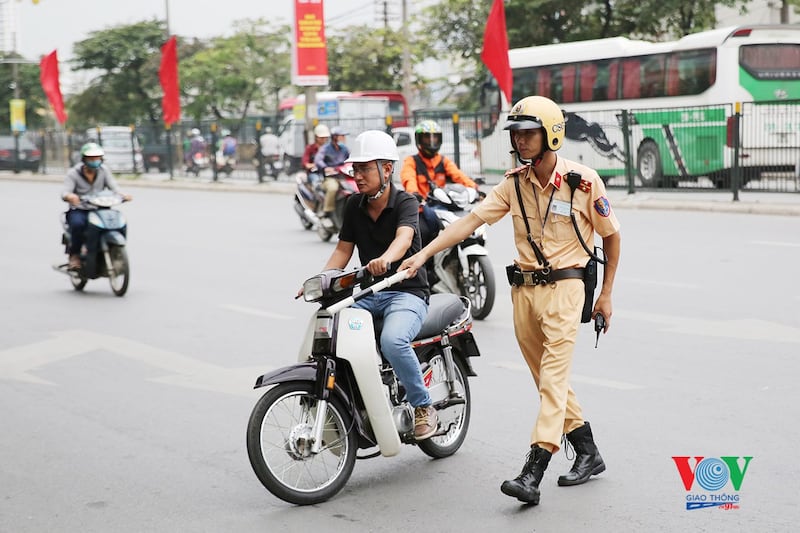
[180, 20, 291, 129]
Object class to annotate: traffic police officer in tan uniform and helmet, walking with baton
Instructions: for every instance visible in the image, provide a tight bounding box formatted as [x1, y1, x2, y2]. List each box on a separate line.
[400, 96, 620, 504]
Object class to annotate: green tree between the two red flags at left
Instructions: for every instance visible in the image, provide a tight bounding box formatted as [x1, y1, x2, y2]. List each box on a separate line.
[68, 20, 166, 125]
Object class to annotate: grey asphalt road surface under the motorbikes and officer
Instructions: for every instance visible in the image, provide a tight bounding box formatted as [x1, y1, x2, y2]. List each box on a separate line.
[0, 177, 800, 532]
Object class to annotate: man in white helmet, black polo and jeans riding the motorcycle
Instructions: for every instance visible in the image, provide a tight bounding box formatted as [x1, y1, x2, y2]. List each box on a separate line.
[304, 130, 438, 440]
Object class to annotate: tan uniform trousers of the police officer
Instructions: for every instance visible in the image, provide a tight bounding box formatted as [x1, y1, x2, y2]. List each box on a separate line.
[511, 279, 585, 453]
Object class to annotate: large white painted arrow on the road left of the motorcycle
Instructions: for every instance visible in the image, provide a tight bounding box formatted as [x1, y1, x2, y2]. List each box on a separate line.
[0, 330, 271, 397]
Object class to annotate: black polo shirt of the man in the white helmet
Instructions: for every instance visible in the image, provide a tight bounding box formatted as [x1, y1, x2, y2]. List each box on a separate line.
[339, 185, 430, 301]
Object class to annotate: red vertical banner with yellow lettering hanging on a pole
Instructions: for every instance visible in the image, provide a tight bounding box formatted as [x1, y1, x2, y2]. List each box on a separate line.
[292, 0, 328, 85]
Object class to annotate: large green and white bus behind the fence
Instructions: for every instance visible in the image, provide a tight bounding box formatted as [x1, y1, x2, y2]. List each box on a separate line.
[481, 25, 800, 186]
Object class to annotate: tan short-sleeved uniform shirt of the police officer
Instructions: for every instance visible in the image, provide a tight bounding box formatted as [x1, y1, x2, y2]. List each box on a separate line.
[472, 157, 619, 270]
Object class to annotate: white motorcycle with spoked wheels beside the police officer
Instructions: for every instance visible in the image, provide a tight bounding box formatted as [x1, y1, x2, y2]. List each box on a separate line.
[247, 269, 480, 505]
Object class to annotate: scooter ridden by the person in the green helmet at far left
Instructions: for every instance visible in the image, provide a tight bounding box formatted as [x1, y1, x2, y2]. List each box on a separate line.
[53, 191, 130, 296]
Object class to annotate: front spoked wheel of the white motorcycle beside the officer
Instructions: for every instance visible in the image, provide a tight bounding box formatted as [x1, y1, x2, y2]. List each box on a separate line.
[247, 382, 358, 505]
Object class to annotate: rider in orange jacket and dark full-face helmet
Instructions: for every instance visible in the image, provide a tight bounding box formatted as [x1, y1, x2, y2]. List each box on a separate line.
[400, 120, 478, 246]
